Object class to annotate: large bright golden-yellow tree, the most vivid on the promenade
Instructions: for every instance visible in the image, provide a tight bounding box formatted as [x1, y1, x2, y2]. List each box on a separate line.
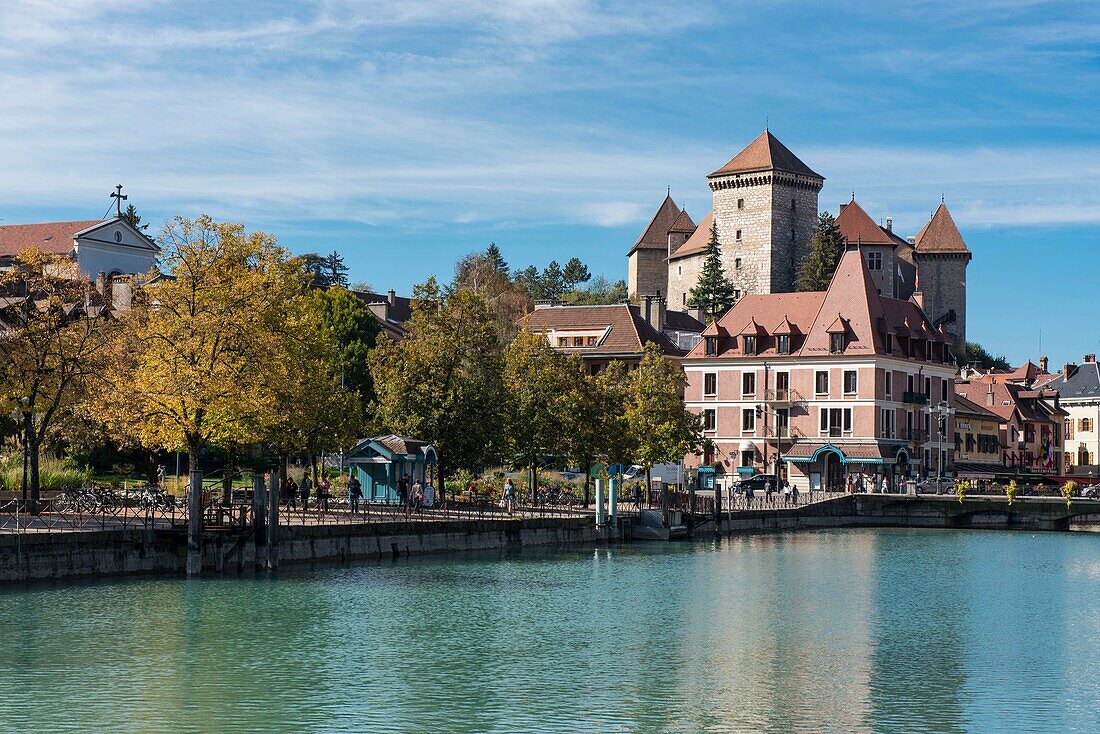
[102, 217, 306, 481]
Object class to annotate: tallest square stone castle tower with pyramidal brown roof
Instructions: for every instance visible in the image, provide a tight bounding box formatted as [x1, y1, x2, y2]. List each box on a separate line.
[696, 130, 825, 295]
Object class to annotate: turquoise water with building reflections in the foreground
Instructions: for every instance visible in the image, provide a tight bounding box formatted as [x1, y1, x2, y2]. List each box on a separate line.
[0, 530, 1100, 733]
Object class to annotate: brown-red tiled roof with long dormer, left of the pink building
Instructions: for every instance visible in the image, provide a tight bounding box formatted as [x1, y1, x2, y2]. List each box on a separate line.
[525, 304, 683, 357]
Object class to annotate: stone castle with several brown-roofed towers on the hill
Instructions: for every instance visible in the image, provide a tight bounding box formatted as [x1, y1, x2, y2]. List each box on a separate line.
[627, 130, 971, 347]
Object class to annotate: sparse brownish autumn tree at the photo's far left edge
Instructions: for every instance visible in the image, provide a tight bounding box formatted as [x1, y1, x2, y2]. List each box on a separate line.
[0, 250, 110, 503]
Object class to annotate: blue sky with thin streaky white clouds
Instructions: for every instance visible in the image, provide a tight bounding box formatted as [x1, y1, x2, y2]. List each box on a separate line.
[0, 0, 1100, 366]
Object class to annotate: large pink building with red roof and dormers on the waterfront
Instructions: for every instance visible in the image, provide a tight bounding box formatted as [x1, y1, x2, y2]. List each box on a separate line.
[683, 245, 957, 491]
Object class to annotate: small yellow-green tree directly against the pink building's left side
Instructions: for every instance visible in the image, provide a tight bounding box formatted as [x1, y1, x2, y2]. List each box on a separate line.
[626, 343, 702, 487]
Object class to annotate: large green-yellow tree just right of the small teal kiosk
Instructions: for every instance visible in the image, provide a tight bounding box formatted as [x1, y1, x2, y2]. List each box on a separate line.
[370, 277, 502, 496]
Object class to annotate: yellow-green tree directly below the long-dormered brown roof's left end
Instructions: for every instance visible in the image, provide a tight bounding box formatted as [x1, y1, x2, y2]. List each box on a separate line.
[504, 329, 583, 503]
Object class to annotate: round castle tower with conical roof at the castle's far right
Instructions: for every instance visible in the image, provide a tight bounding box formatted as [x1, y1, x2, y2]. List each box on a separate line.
[913, 201, 972, 348]
